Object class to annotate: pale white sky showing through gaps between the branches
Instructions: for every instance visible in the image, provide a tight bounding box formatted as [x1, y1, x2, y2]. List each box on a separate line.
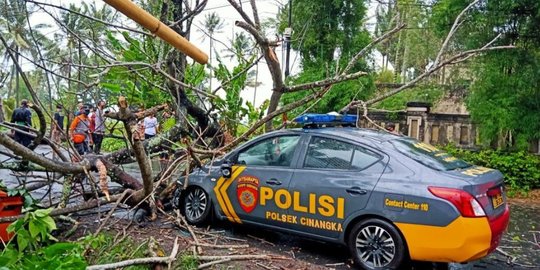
[25, 0, 380, 107]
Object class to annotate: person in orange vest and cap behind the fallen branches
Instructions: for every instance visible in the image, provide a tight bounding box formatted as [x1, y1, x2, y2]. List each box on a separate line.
[69, 105, 92, 155]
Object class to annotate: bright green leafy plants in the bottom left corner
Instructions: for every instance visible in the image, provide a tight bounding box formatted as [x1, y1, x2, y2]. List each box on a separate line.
[0, 209, 86, 269]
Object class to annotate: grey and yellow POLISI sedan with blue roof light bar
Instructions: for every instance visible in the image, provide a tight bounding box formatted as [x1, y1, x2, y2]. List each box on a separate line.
[175, 114, 509, 269]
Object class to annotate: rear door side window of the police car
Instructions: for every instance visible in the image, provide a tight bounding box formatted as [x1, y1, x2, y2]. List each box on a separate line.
[304, 137, 380, 170]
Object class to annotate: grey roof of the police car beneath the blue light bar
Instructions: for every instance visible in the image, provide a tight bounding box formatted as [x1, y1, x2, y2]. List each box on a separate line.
[272, 127, 402, 143]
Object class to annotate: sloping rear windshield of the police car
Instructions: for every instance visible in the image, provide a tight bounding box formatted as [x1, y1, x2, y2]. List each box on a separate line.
[391, 138, 471, 171]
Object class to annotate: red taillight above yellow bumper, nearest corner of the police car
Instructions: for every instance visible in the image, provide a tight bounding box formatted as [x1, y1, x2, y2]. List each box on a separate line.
[428, 187, 486, 217]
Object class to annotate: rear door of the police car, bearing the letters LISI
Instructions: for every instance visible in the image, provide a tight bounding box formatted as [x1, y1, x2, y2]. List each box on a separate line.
[289, 135, 385, 238]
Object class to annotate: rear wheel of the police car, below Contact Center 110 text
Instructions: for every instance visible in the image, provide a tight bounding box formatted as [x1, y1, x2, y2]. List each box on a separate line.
[348, 218, 406, 269]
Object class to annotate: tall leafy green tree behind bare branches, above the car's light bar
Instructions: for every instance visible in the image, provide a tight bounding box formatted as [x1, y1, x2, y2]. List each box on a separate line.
[276, 0, 374, 114]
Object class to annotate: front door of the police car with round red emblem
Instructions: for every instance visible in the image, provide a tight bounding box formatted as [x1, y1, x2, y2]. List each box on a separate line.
[219, 134, 301, 227]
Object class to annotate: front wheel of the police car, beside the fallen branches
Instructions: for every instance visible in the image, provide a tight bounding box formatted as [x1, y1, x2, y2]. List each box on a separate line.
[183, 187, 210, 225]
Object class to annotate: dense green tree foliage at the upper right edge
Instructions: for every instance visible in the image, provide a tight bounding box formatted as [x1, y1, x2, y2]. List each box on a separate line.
[432, 0, 540, 150]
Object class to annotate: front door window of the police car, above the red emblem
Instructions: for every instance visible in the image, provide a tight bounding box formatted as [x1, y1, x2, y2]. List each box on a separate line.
[238, 135, 300, 167]
